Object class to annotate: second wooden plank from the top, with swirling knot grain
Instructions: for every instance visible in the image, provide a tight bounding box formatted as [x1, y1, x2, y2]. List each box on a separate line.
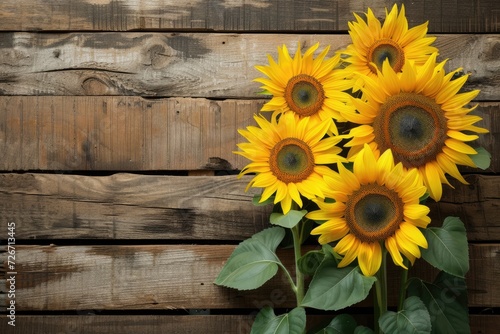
[0, 32, 500, 101]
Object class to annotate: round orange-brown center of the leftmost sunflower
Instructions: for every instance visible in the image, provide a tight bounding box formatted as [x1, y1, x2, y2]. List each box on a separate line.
[269, 138, 315, 183]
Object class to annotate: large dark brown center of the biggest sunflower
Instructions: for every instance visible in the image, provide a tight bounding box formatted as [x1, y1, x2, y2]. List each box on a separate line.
[373, 93, 448, 168]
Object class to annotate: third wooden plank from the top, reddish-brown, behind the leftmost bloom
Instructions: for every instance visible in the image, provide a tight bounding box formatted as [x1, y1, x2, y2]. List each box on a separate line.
[0, 96, 500, 172]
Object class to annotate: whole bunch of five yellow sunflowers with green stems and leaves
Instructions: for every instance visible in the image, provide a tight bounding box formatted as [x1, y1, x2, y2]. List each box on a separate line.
[215, 5, 490, 334]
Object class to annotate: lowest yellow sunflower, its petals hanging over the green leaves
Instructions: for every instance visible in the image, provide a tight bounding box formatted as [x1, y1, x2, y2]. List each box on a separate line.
[307, 145, 430, 276]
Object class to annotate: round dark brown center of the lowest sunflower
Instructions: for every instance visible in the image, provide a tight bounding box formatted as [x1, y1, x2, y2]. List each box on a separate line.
[346, 184, 404, 242]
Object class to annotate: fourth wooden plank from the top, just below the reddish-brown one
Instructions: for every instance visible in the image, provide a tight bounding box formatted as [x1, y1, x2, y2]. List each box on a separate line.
[0, 174, 500, 241]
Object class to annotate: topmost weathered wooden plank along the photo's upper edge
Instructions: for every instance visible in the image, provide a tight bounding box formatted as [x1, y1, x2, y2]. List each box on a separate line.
[0, 0, 500, 32]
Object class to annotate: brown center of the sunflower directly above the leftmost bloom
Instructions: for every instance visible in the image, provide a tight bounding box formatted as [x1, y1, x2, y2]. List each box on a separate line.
[284, 74, 325, 116]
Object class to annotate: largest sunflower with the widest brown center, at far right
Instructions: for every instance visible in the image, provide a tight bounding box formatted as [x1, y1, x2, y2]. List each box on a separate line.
[343, 53, 488, 201]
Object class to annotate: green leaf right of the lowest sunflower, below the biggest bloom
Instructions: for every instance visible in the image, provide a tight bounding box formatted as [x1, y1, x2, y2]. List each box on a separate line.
[422, 217, 469, 277]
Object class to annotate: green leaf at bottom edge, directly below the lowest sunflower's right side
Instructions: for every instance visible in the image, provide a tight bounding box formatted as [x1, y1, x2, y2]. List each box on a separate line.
[378, 296, 432, 334]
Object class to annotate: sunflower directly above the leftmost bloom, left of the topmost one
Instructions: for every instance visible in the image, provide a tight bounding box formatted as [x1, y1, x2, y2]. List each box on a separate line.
[254, 43, 352, 134]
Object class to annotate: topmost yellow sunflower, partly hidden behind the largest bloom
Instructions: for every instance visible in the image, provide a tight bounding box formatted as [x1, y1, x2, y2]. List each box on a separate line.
[340, 5, 437, 82]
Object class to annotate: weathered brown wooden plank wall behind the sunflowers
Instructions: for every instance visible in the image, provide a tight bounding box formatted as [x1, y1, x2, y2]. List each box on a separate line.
[0, 0, 500, 334]
